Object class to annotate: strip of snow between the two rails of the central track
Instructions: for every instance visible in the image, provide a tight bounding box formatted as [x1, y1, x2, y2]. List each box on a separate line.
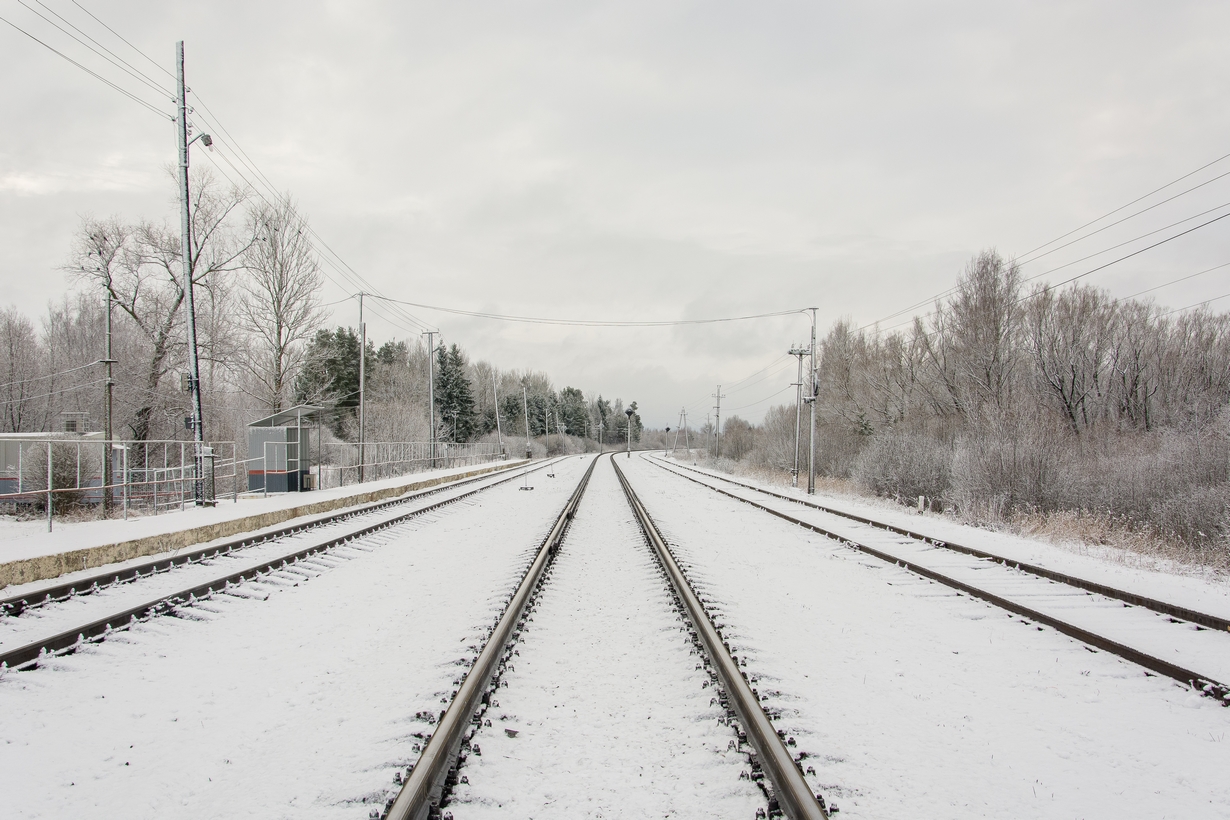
[449, 459, 764, 820]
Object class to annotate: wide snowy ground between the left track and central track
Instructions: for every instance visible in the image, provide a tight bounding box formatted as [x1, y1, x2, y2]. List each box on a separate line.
[0, 459, 587, 820]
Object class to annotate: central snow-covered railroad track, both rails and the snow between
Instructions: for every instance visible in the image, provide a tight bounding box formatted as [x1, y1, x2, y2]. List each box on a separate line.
[383, 461, 827, 820]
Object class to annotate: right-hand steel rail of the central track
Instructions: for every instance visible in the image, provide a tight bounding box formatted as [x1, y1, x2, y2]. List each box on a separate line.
[611, 459, 829, 820]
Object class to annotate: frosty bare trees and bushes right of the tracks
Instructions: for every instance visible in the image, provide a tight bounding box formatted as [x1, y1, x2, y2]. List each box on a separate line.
[703, 251, 1230, 557]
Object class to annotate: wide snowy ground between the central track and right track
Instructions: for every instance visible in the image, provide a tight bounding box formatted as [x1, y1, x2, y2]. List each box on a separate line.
[621, 459, 1230, 819]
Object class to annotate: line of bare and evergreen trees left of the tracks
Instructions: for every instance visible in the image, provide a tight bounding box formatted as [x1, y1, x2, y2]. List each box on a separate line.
[0, 171, 641, 457]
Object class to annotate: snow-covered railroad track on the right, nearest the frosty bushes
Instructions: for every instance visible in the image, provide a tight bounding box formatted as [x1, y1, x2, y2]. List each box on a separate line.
[649, 459, 1230, 707]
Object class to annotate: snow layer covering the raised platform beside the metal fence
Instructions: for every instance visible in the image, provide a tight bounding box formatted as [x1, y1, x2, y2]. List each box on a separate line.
[0, 462, 514, 570]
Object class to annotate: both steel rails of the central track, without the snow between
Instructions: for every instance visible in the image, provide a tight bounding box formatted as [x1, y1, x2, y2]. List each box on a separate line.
[371, 457, 828, 820]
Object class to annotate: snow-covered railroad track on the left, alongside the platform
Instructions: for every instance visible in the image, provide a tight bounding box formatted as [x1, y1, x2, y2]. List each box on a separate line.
[0, 460, 558, 671]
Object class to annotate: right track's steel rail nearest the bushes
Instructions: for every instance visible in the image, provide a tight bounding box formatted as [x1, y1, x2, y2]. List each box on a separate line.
[651, 457, 1230, 631]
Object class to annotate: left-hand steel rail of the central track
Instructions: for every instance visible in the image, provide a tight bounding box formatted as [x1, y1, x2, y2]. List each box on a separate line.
[385, 457, 598, 820]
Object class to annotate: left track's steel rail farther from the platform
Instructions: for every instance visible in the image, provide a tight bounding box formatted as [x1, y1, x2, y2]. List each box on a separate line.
[0, 454, 563, 671]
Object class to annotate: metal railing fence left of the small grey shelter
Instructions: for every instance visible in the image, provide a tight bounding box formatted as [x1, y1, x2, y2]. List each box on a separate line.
[0, 436, 240, 529]
